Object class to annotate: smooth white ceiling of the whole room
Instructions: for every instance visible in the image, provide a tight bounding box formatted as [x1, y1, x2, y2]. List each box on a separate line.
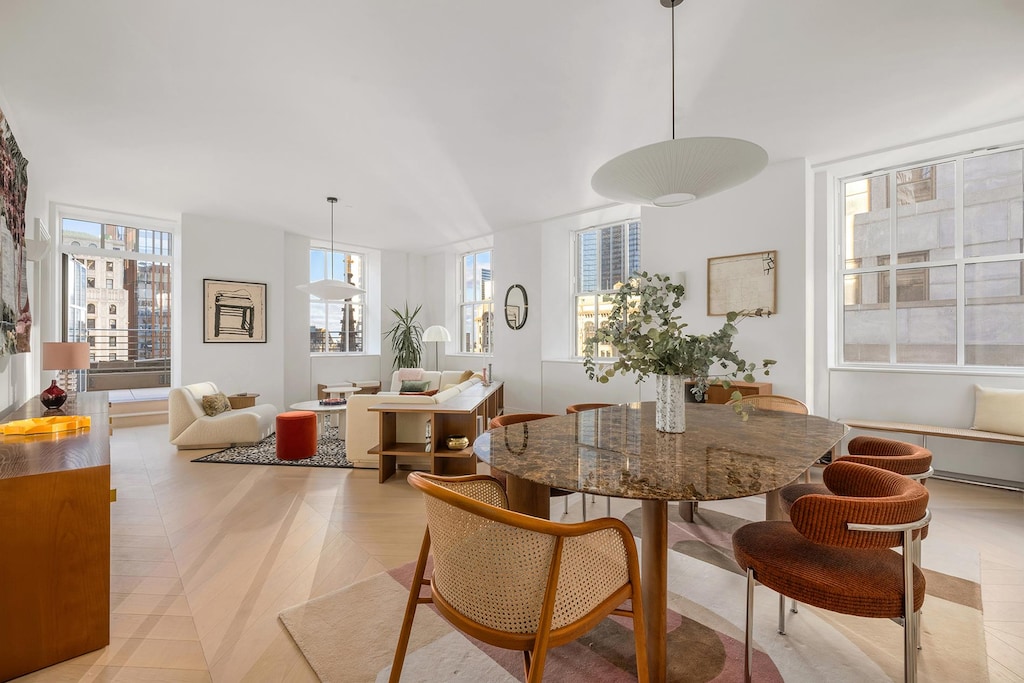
[0, 0, 1024, 251]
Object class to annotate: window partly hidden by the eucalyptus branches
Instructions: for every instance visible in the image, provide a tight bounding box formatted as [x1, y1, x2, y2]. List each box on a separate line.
[573, 218, 640, 356]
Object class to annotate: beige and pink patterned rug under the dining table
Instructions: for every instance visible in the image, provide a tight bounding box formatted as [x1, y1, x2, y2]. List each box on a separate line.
[281, 505, 988, 683]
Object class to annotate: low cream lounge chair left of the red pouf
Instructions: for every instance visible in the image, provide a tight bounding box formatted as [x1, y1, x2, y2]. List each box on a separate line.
[167, 382, 278, 449]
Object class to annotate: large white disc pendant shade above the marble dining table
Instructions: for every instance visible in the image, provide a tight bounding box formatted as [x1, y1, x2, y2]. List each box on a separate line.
[591, 137, 768, 207]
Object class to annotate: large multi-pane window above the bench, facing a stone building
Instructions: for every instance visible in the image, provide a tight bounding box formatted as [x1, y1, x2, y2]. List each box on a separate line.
[838, 147, 1024, 368]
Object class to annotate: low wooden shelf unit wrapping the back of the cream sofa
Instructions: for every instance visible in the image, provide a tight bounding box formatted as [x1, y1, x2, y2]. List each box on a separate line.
[369, 382, 505, 483]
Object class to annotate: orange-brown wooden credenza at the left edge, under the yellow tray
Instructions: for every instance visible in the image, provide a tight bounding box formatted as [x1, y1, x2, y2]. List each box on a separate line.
[0, 391, 112, 681]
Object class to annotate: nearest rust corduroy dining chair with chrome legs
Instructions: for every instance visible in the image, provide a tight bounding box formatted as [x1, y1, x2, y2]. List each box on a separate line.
[732, 461, 931, 682]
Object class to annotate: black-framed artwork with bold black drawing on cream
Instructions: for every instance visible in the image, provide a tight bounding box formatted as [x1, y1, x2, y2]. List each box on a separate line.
[203, 279, 266, 344]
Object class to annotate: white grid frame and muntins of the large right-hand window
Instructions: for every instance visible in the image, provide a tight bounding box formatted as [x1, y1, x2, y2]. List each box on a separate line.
[828, 142, 1024, 375]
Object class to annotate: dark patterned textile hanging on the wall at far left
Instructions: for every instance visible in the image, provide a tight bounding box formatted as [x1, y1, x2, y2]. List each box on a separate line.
[0, 105, 32, 355]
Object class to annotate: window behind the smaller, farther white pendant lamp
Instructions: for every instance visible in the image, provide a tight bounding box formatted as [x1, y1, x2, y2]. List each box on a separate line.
[309, 247, 366, 353]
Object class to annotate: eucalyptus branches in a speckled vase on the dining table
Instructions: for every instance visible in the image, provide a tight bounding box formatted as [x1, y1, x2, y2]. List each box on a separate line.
[584, 271, 775, 432]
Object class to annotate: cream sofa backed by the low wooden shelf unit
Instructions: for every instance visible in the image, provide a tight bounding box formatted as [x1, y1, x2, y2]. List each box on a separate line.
[345, 371, 480, 469]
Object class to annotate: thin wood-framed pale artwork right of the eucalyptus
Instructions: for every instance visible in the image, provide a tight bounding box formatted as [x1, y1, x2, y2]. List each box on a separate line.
[708, 251, 776, 315]
